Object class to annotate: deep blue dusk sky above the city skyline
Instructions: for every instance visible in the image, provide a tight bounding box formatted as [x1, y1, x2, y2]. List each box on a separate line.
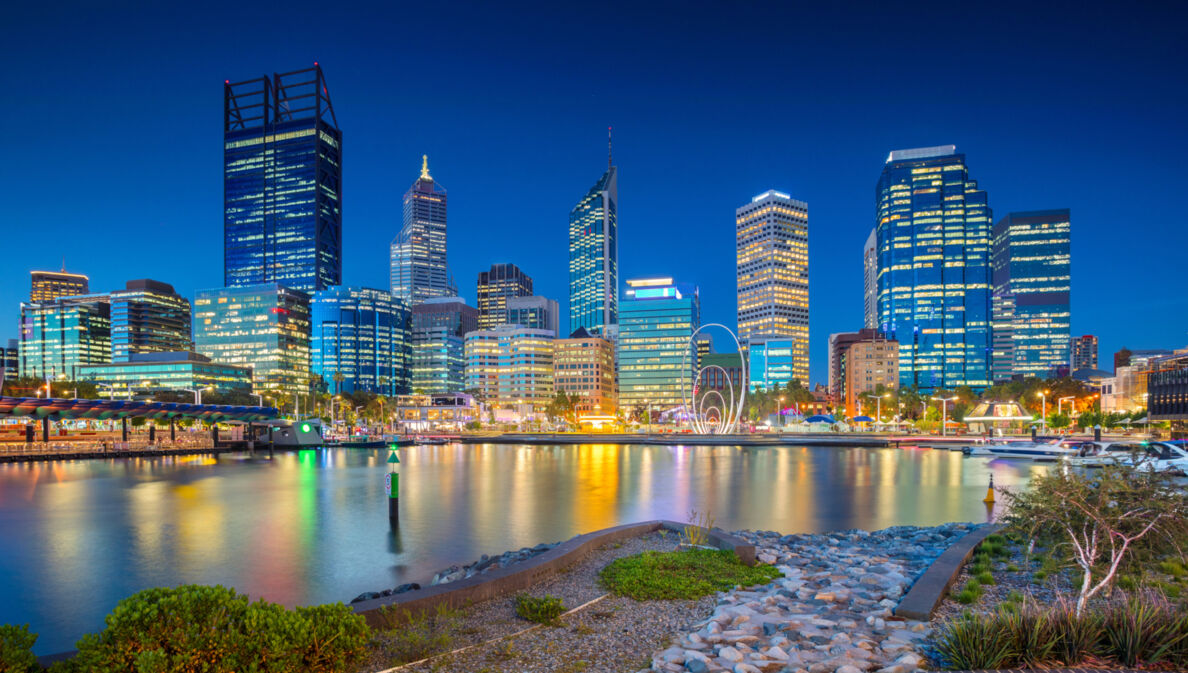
[0, 1, 1188, 380]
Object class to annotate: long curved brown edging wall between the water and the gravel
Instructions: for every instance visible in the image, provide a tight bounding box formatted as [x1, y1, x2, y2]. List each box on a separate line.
[352, 521, 754, 627]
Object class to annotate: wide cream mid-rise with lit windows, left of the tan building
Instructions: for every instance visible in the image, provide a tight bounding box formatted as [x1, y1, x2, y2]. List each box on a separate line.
[466, 325, 554, 417]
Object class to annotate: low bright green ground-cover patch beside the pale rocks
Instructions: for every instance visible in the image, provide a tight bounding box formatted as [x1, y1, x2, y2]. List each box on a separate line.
[601, 549, 781, 600]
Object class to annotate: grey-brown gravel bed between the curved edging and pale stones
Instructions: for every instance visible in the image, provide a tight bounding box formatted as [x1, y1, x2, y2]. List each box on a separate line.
[362, 533, 716, 673]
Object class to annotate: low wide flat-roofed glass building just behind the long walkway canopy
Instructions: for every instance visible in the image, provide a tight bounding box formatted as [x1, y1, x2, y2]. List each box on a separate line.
[78, 351, 253, 407]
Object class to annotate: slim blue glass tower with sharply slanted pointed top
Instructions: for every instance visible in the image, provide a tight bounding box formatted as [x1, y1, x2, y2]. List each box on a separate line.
[569, 151, 619, 333]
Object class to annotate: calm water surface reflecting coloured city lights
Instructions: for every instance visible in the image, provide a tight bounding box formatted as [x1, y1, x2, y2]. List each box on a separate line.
[0, 445, 1047, 654]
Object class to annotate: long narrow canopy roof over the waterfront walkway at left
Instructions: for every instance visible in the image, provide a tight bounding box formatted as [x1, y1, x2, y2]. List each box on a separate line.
[0, 397, 279, 421]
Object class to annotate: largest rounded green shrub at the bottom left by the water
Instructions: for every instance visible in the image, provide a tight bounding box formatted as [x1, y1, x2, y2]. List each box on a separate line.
[72, 585, 371, 673]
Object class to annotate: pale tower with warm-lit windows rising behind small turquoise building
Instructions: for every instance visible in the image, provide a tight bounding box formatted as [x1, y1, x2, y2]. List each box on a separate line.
[734, 189, 809, 385]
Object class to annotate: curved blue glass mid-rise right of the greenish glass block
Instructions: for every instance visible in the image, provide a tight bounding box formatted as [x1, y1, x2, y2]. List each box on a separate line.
[310, 285, 412, 396]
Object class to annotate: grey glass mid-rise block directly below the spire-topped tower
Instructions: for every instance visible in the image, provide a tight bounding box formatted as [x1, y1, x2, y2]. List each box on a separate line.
[412, 297, 479, 395]
